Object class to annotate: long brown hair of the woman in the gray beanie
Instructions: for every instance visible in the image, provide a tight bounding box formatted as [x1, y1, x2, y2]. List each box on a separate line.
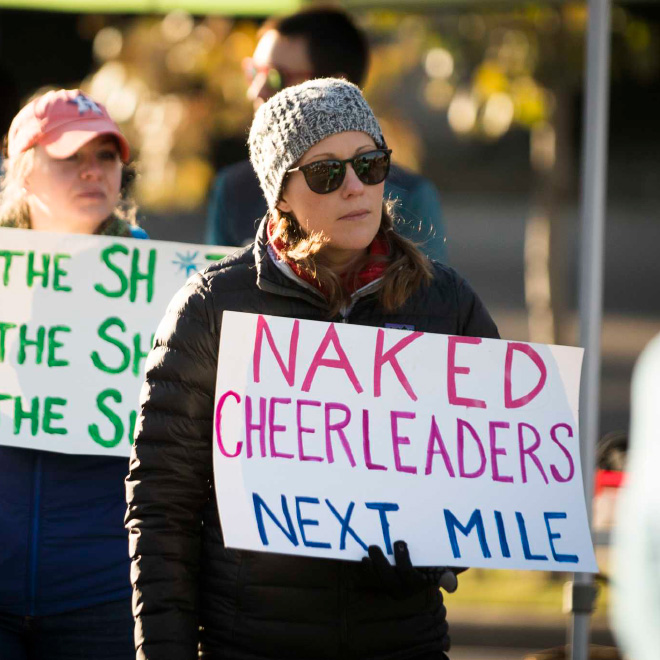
[271, 202, 433, 317]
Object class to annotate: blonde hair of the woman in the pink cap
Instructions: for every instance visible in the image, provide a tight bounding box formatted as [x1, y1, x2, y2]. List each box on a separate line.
[0, 147, 137, 233]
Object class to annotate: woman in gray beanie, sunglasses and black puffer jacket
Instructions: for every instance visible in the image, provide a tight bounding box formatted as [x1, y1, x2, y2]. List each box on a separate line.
[127, 79, 498, 660]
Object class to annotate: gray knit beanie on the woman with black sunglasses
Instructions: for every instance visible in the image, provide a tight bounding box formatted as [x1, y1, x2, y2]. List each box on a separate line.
[249, 78, 387, 210]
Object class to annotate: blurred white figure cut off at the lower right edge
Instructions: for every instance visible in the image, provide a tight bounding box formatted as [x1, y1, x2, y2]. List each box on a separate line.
[610, 335, 660, 660]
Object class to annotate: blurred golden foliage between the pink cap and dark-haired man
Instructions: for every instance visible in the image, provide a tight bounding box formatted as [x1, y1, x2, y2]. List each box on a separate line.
[80, 11, 256, 210]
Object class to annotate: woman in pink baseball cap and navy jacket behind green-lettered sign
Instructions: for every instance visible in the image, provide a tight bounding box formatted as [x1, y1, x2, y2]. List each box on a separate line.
[0, 89, 146, 660]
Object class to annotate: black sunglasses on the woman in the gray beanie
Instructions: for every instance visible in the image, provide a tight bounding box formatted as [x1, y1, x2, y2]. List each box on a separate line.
[287, 149, 392, 195]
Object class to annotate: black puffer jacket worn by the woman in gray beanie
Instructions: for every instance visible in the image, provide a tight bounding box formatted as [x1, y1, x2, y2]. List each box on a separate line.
[126, 218, 498, 660]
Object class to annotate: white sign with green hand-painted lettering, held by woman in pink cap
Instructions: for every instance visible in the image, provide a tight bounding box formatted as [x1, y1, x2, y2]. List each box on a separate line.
[0, 228, 236, 456]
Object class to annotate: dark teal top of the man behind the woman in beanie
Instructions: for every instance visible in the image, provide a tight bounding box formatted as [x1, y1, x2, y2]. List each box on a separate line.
[206, 160, 447, 263]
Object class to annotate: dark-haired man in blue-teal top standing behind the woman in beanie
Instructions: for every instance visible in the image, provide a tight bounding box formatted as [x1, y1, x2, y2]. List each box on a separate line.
[206, 7, 447, 263]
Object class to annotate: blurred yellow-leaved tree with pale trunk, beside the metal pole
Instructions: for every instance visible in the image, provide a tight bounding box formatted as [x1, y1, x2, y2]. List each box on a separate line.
[358, 0, 660, 343]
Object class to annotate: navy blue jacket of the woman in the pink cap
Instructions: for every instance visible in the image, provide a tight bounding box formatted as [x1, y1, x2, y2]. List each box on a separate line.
[0, 227, 146, 616]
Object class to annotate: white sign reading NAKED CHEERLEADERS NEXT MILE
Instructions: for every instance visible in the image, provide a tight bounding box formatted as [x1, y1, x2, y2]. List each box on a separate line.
[214, 312, 597, 572]
